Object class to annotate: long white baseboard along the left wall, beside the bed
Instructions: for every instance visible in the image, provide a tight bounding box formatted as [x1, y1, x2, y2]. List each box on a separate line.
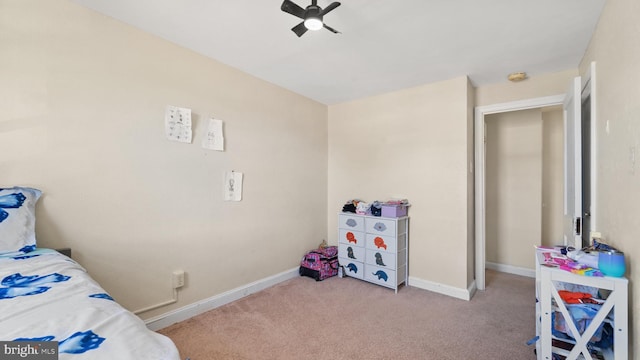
[145, 267, 300, 331]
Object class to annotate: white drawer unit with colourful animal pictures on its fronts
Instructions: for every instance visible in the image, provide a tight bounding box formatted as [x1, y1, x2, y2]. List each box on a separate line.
[338, 213, 409, 293]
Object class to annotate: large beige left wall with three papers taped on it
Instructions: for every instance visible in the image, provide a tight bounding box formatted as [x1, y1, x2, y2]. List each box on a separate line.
[0, 0, 327, 317]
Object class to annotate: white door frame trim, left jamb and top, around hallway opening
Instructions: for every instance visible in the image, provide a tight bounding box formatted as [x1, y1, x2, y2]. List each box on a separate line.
[474, 94, 565, 290]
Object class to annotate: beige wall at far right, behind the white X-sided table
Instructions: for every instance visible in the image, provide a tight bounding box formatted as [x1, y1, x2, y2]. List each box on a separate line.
[580, 0, 640, 359]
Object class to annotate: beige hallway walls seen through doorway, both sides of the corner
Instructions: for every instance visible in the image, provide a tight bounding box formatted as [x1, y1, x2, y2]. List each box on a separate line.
[485, 107, 564, 270]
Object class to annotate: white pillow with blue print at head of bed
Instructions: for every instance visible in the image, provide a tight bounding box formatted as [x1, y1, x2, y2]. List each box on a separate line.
[0, 187, 42, 253]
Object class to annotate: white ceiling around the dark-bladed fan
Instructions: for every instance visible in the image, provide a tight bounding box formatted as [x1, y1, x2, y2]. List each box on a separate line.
[73, 0, 605, 105]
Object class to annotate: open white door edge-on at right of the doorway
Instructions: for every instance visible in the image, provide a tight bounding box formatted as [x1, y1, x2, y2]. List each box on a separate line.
[564, 76, 582, 249]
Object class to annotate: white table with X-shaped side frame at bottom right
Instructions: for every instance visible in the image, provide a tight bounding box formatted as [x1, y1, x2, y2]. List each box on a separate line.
[536, 249, 629, 360]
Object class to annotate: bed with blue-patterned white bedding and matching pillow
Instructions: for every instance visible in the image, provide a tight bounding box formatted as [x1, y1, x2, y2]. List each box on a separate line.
[0, 187, 180, 360]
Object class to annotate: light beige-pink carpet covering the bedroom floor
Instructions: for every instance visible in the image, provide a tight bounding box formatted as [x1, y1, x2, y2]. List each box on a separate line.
[159, 270, 535, 360]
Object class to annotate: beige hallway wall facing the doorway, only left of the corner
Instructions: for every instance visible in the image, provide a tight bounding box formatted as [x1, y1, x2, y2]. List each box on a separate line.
[485, 109, 542, 269]
